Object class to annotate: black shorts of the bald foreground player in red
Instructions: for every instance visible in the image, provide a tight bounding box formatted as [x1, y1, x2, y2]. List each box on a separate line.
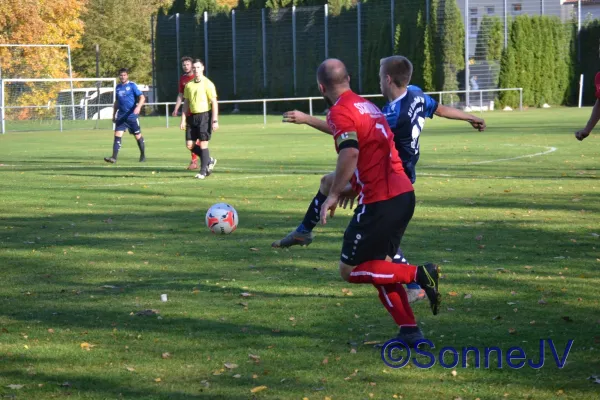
[340, 192, 415, 266]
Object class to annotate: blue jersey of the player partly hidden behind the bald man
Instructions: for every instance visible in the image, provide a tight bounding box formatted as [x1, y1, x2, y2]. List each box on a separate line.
[383, 85, 438, 183]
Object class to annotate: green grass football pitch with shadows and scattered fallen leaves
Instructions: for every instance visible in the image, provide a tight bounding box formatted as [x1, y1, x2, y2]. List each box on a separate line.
[0, 108, 600, 400]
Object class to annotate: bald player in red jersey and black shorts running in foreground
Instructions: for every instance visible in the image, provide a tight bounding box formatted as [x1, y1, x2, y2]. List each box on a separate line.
[317, 59, 441, 346]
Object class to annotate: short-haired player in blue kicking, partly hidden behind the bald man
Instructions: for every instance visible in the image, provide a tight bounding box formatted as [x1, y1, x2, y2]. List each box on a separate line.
[271, 56, 485, 301]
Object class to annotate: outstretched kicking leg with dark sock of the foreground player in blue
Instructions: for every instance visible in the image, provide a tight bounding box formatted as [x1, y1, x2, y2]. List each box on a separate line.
[271, 172, 342, 247]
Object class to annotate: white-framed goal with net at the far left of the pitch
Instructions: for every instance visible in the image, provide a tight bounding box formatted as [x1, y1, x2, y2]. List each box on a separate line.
[0, 78, 116, 132]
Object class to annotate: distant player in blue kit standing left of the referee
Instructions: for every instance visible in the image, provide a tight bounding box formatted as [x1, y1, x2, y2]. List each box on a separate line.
[104, 68, 146, 164]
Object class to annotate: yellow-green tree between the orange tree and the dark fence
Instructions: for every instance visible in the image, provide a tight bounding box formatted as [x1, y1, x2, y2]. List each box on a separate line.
[73, 0, 171, 84]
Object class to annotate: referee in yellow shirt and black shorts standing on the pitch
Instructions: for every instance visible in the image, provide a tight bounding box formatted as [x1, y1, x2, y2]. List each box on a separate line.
[180, 59, 219, 179]
